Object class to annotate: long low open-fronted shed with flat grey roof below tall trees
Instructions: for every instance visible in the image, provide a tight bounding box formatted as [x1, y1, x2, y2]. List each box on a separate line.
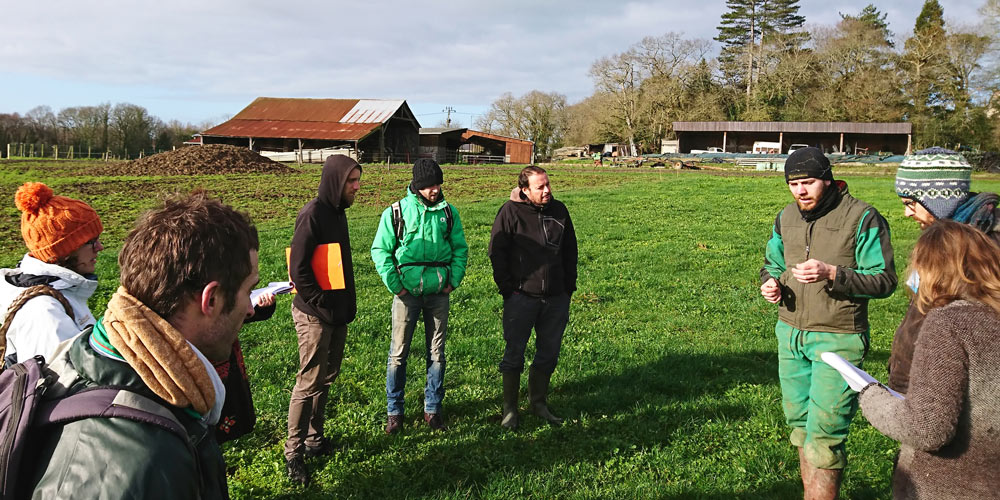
[674, 122, 913, 154]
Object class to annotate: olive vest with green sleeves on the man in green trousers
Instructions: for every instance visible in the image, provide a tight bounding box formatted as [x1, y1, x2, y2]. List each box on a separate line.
[761, 181, 896, 333]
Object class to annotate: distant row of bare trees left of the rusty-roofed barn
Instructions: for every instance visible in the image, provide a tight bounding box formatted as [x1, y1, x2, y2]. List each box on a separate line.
[0, 103, 211, 158]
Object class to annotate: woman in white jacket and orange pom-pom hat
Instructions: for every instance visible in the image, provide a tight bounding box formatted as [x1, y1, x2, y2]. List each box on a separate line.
[0, 182, 104, 366]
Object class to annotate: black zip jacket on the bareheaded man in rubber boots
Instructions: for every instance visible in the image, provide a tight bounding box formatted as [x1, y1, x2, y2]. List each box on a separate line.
[489, 188, 577, 297]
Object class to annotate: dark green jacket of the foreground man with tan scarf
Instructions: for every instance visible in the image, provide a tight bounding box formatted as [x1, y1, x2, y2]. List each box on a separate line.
[21, 328, 229, 500]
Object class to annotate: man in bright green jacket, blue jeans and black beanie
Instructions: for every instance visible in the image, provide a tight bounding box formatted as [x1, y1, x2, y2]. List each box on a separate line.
[372, 158, 469, 434]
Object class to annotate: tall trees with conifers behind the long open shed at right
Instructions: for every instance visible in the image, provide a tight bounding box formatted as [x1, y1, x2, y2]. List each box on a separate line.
[475, 0, 1000, 157]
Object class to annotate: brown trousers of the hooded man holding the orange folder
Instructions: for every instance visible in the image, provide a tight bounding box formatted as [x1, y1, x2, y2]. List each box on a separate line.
[285, 305, 347, 460]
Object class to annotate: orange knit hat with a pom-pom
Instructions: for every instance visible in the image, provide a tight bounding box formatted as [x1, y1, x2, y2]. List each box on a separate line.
[14, 182, 104, 263]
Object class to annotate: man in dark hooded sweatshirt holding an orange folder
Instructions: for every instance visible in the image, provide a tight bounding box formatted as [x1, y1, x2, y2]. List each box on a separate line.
[285, 155, 361, 484]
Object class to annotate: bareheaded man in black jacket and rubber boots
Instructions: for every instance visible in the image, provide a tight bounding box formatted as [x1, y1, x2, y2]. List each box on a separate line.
[489, 166, 577, 429]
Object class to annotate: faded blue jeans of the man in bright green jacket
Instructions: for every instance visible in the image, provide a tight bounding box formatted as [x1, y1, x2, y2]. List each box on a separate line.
[385, 293, 448, 415]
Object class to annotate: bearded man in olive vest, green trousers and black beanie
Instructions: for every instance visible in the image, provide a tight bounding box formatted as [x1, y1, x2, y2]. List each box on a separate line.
[760, 148, 896, 499]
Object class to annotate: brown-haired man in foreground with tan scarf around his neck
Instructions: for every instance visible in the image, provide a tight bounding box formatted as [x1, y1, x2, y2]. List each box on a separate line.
[19, 192, 258, 499]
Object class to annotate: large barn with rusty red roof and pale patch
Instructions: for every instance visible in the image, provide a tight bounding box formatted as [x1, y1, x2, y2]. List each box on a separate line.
[201, 97, 420, 162]
